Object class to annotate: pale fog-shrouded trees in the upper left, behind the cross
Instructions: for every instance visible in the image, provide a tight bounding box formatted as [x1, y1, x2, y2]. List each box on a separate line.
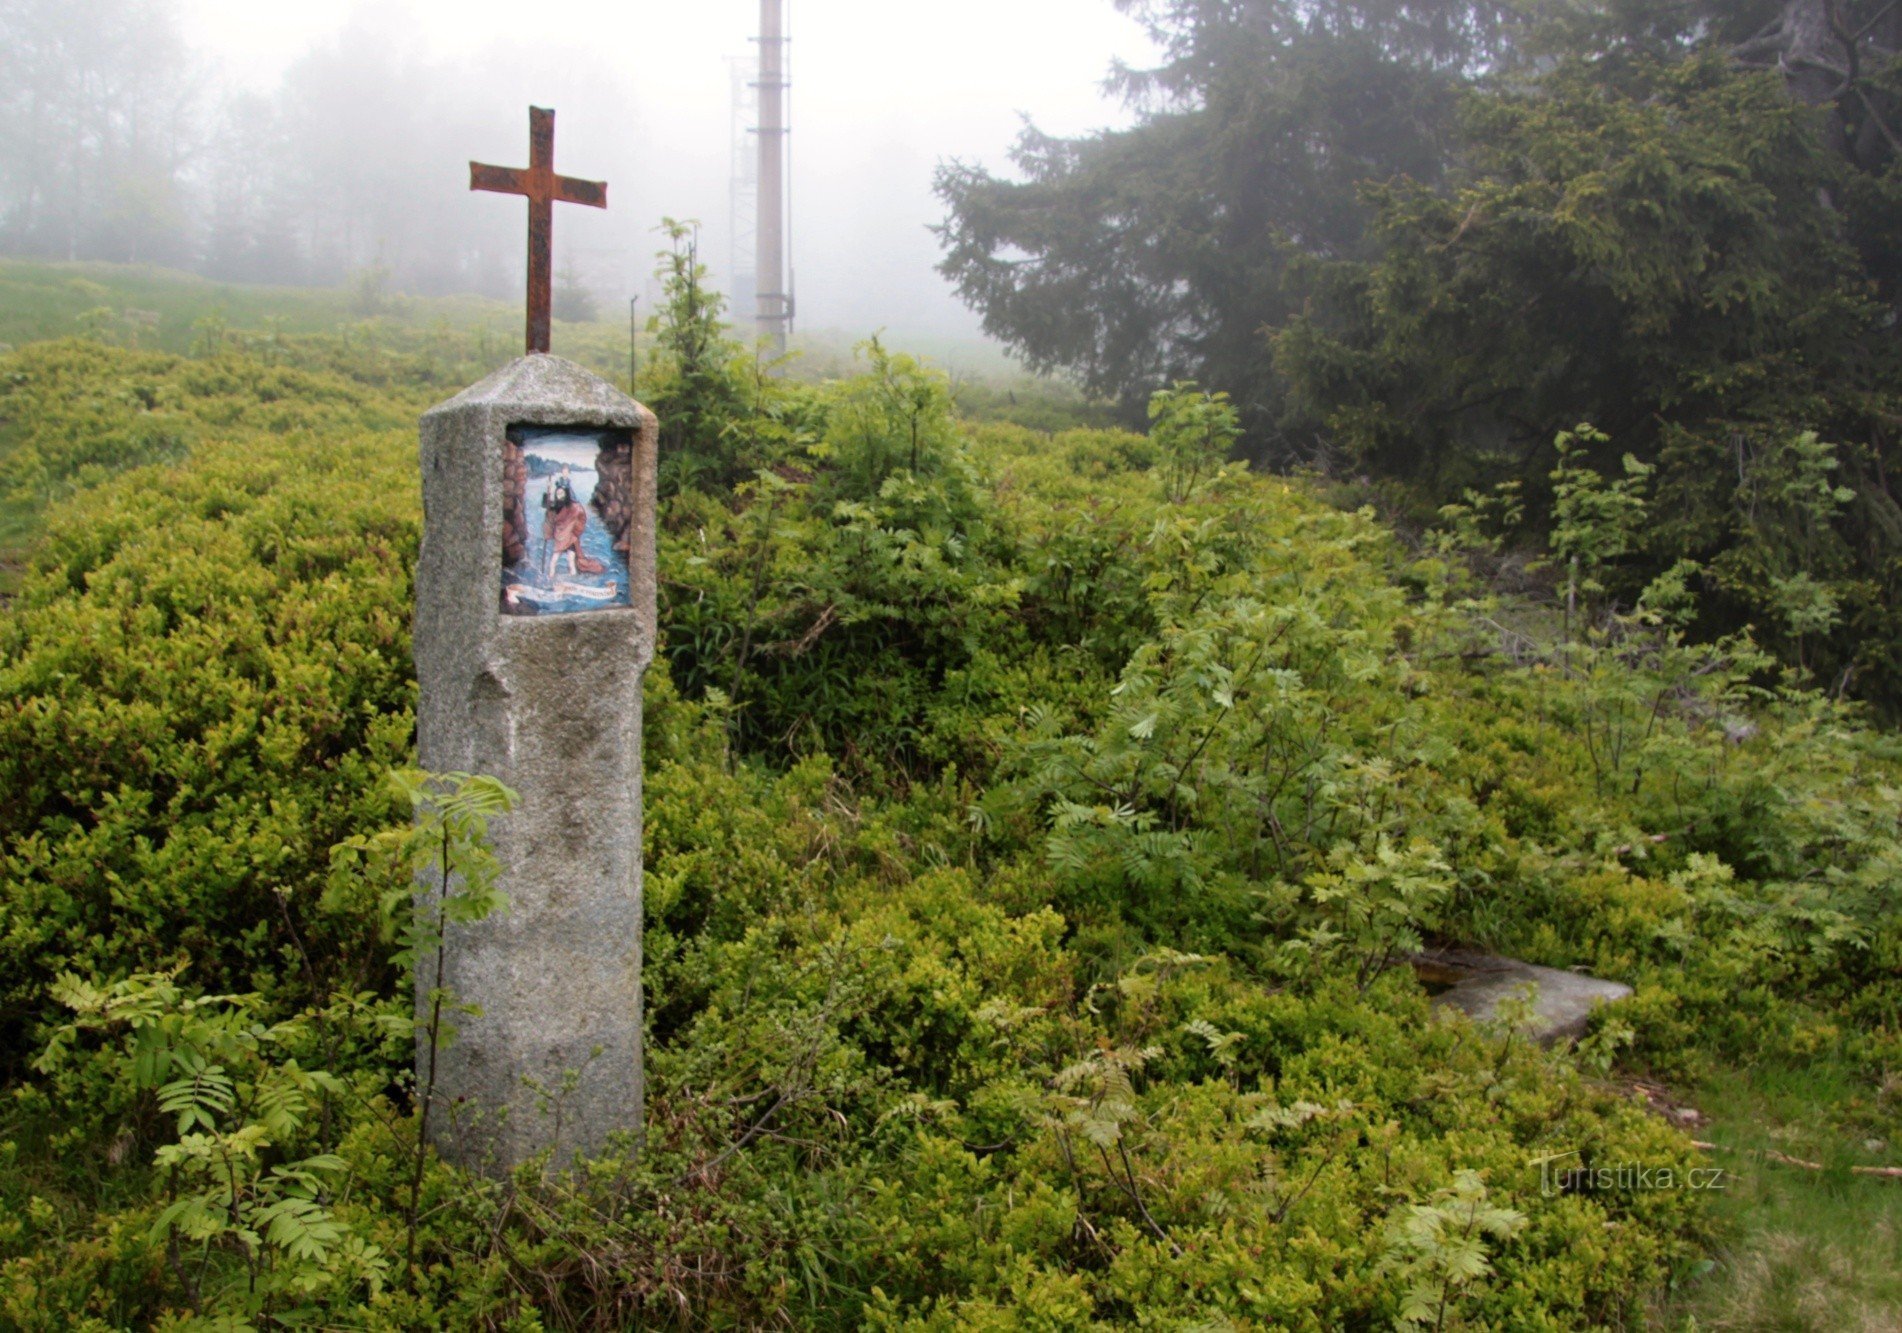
[0, 0, 631, 302]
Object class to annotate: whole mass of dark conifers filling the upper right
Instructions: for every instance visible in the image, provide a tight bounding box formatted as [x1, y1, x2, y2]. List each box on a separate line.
[938, 0, 1902, 711]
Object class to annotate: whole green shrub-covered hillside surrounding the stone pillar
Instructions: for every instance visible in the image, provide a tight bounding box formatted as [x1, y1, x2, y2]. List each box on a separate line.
[0, 275, 1902, 1329]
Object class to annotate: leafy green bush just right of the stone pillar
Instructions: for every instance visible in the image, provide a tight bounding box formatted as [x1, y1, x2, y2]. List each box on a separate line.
[662, 340, 1018, 770]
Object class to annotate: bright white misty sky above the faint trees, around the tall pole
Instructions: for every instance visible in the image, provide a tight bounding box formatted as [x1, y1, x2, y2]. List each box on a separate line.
[184, 0, 1151, 335]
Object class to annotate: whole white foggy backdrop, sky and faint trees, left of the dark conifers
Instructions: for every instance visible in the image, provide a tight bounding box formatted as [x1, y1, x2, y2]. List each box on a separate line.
[0, 0, 1149, 337]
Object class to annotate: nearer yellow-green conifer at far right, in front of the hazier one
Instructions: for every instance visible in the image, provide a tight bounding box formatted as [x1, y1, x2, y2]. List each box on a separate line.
[1274, 55, 1902, 704]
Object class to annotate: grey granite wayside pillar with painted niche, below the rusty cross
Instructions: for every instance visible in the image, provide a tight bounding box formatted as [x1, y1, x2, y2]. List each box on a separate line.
[415, 356, 658, 1169]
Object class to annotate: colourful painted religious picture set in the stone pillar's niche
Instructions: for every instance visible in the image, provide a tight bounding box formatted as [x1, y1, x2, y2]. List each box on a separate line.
[502, 426, 633, 616]
